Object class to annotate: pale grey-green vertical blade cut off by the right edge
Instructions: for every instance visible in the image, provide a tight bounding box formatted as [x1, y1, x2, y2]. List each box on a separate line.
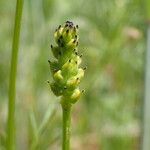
[141, 0, 150, 150]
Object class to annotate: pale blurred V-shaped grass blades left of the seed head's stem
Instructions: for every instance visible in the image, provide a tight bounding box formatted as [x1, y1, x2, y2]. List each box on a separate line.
[28, 106, 59, 150]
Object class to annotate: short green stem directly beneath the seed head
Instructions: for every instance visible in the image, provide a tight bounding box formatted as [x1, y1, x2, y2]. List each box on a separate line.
[62, 105, 71, 150]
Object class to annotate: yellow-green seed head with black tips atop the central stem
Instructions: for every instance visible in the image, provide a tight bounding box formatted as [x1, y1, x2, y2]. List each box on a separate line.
[48, 21, 86, 104]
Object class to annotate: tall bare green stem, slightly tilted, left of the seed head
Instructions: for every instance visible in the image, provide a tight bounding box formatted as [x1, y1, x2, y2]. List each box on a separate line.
[7, 0, 23, 150]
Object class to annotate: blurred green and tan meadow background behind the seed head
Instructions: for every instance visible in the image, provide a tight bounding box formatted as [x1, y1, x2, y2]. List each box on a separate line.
[0, 0, 146, 150]
